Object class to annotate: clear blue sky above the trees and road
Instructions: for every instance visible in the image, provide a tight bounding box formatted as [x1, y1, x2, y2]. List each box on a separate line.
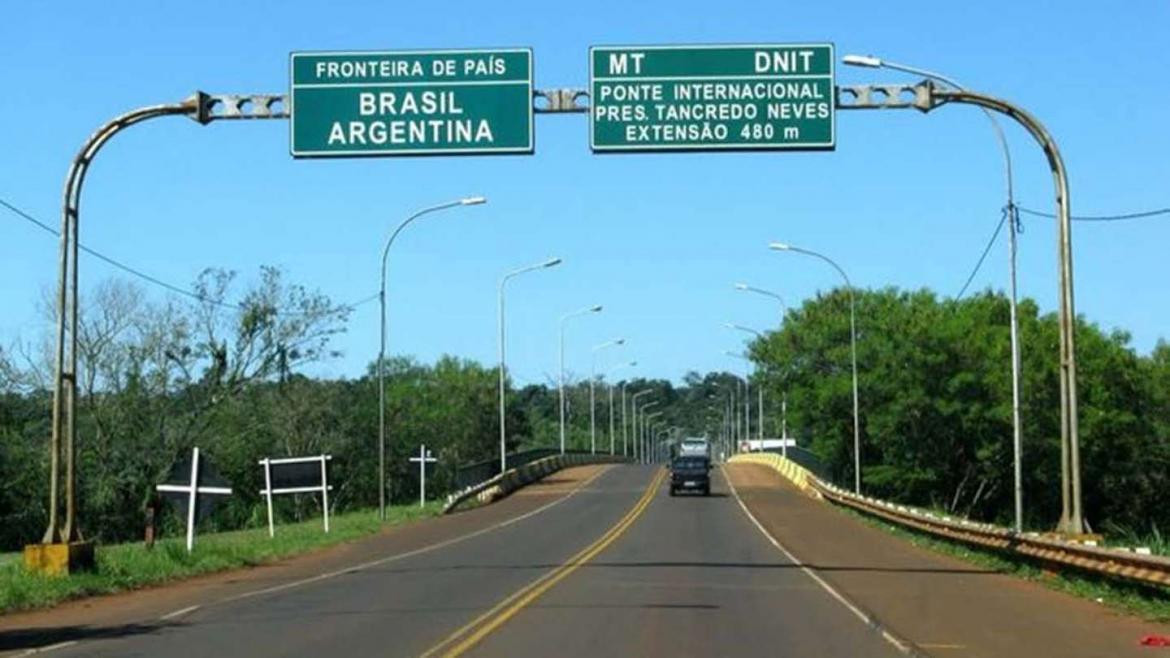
[0, 0, 1170, 383]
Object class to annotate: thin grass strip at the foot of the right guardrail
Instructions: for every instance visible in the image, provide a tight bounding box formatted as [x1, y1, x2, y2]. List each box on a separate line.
[834, 505, 1170, 623]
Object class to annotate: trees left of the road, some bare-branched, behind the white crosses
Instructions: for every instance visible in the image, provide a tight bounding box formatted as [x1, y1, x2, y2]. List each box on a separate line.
[0, 268, 687, 550]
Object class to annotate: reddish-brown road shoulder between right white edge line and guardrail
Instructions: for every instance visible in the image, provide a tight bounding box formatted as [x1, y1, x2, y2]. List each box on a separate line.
[727, 464, 1168, 657]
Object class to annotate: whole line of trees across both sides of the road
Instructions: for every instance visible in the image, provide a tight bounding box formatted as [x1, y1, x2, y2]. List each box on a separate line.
[0, 268, 1170, 550]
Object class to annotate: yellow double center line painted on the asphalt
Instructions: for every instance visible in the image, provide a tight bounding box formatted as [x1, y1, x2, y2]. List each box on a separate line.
[422, 471, 666, 658]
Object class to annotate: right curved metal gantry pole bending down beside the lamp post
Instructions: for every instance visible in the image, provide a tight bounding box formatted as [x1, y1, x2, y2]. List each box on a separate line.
[928, 85, 1085, 534]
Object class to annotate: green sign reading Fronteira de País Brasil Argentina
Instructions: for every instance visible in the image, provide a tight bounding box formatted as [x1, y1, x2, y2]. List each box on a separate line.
[289, 48, 534, 157]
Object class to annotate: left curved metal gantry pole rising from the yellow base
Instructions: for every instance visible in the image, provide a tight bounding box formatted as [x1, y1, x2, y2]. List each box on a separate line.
[41, 96, 199, 543]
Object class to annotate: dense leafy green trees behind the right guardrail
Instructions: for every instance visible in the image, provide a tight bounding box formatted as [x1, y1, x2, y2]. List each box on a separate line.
[752, 289, 1170, 532]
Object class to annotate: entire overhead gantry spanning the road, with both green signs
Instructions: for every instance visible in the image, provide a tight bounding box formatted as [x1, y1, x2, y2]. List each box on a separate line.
[25, 43, 1083, 570]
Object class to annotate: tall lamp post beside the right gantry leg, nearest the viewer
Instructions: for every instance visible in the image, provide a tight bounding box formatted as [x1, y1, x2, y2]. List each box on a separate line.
[842, 55, 1024, 533]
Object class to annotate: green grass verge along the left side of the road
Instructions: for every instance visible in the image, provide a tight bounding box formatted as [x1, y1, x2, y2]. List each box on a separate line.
[0, 501, 442, 614]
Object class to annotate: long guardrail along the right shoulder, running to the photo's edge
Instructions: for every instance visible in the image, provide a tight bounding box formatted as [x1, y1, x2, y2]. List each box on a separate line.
[732, 453, 1170, 587]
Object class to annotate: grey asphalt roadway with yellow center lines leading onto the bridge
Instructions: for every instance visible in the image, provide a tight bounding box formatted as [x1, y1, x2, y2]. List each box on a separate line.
[36, 466, 897, 657]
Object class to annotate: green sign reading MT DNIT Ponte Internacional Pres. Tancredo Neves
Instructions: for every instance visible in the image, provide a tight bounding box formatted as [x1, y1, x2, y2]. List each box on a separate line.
[590, 43, 837, 152]
